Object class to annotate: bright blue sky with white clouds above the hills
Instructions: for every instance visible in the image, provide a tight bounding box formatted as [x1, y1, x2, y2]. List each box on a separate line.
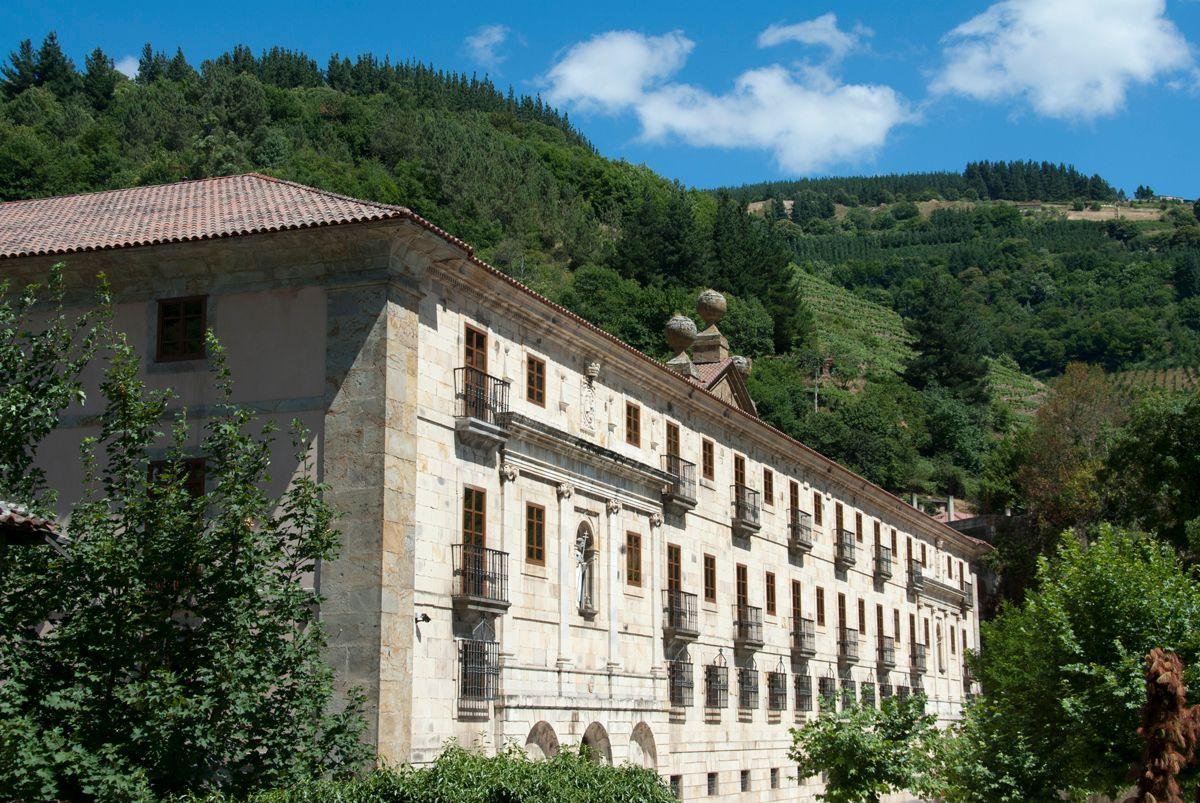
[0, 0, 1200, 197]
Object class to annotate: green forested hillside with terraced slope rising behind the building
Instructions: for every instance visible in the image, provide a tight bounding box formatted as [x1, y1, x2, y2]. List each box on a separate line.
[0, 36, 1200, 506]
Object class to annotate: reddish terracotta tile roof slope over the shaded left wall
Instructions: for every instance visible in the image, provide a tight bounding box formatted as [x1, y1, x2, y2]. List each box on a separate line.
[0, 173, 413, 259]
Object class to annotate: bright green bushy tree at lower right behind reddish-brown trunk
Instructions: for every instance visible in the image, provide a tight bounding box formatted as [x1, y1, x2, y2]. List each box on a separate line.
[937, 526, 1200, 802]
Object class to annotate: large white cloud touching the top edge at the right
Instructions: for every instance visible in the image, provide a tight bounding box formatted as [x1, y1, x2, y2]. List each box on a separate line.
[931, 0, 1193, 120]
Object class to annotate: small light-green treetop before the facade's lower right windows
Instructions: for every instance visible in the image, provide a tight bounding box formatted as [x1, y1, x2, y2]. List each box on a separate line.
[790, 695, 936, 803]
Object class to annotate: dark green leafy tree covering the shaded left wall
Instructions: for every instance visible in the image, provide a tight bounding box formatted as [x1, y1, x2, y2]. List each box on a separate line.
[0, 280, 368, 801]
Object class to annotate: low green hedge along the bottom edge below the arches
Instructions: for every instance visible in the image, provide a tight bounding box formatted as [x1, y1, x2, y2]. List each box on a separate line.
[204, 744, 676, 803]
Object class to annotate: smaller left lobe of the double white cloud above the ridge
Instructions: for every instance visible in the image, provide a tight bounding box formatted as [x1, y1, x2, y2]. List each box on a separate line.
[546, 31, 694, 112]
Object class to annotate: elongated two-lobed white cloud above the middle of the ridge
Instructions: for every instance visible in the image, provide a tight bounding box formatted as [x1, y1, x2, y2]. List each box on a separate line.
[546, 31, 913, 173]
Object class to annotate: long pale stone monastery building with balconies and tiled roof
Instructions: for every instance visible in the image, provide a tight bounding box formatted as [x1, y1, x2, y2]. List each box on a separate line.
[0, 175, 986, 801]
